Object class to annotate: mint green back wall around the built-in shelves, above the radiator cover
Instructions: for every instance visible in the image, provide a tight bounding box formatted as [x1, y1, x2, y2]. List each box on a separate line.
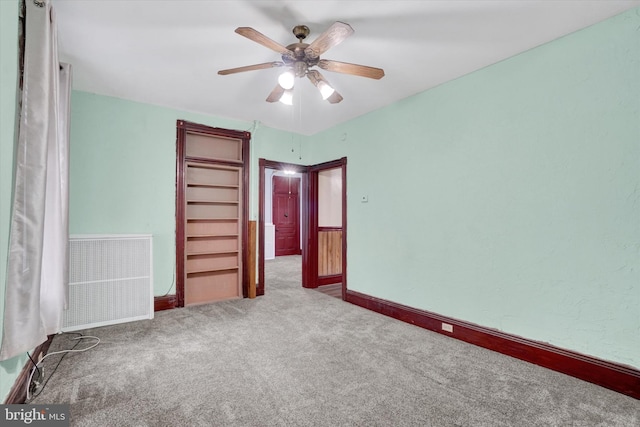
[69, 91, 304, 295]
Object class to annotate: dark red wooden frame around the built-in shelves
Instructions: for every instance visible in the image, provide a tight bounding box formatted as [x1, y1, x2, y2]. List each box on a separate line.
[176, 120, 251, 307]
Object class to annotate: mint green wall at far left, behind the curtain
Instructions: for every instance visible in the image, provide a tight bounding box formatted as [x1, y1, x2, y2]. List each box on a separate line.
[0, 0, 27, 402]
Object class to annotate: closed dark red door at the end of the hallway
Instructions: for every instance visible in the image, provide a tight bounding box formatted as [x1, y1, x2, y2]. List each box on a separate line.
[273, 176, 301, 256]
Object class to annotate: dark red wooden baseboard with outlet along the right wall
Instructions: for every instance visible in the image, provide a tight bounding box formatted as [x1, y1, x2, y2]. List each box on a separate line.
[346, 290, 640, 399]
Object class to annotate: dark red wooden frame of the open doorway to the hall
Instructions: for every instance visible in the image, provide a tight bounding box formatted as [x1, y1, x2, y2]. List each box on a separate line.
[256, 157, 347, 300]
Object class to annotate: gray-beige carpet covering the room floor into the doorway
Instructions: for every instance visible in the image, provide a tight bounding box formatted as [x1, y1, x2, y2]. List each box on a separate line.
[27, 257, 640, 427]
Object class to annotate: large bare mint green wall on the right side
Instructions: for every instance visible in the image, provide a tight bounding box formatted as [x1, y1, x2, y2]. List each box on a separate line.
[309, 9, 640, 367]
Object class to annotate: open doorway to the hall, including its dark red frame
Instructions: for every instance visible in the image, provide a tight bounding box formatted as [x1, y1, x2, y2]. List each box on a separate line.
[256, 158, 347, 299]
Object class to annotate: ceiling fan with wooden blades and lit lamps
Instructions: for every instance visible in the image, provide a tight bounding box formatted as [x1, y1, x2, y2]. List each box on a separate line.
[218, 21, 384, 104]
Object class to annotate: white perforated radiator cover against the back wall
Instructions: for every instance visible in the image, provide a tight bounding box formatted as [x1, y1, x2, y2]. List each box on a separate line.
[62, 234, 153, 332]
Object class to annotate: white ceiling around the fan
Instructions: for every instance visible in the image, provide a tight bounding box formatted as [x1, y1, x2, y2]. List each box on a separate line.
[52, 0, 640, 135]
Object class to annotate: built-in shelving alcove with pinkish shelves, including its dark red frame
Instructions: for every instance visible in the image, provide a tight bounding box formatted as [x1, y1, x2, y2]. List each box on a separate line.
[176, 121, 250, 307]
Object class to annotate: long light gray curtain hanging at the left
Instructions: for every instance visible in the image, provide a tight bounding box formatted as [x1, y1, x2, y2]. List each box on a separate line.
[0, 0, 71, 360]
